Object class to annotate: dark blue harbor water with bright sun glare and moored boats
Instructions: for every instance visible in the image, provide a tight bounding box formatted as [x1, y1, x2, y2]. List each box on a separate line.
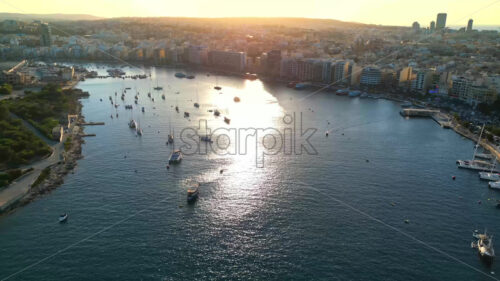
[0, 64, 500, 280]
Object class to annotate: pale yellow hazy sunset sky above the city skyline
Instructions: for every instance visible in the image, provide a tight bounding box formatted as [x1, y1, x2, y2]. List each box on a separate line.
[0, 0, 500, 26]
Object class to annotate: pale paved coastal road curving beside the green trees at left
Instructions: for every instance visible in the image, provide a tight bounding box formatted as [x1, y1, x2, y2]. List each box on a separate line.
[0, 115, 66, 210]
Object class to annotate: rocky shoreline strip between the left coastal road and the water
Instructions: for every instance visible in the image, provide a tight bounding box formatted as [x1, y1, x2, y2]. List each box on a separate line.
[0, 82, 85, 216]
